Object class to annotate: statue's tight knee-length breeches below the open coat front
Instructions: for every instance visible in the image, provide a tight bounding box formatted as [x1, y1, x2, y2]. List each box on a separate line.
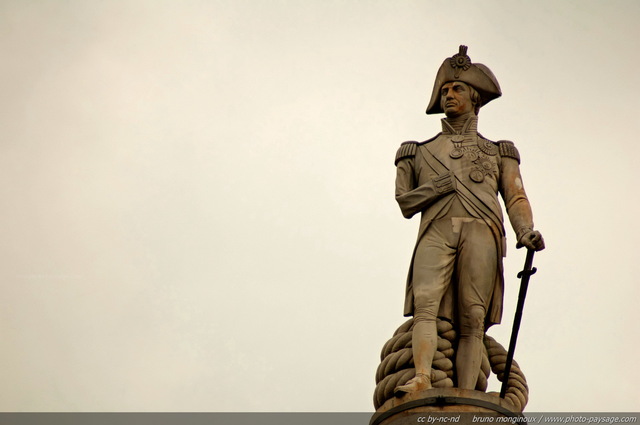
[413, 217, 498, 335]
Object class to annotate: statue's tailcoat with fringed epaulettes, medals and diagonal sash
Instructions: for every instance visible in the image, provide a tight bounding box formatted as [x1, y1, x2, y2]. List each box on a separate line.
[396, 117, 533, 328]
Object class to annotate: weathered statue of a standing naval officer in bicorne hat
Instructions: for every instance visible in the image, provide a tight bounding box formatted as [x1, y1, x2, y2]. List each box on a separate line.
[395, 46, 544, 393]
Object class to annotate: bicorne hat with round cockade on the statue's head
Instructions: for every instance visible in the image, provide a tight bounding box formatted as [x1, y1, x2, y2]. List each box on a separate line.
[427, 46, 502, 114]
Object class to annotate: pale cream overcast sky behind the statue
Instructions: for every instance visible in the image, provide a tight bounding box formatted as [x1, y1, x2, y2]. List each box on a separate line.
[0, 0, 640, 412]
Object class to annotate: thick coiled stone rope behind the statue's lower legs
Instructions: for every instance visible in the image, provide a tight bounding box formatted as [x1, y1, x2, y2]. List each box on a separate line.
[373, 319, 529, 411]
